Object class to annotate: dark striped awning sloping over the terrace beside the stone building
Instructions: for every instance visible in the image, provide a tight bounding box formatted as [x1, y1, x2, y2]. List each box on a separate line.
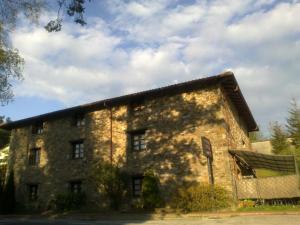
[229, 150, 297, 173]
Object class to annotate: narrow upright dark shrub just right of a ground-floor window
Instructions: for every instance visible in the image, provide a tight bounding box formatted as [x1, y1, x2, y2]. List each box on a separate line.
[142, 171, 163, 209]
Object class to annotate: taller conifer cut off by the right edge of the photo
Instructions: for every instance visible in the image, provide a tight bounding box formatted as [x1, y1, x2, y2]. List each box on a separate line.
[286, 99, 300, 150]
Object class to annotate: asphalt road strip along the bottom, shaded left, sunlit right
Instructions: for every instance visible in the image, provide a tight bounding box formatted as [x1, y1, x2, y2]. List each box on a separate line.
[0, 215, 300, 225]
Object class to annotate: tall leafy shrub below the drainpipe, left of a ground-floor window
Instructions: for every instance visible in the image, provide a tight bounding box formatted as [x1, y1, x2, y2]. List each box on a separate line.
[92, 163, 129, 210]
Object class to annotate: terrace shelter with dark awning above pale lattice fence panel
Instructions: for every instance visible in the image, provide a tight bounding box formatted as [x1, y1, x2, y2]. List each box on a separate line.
[229, 150, 300, 199]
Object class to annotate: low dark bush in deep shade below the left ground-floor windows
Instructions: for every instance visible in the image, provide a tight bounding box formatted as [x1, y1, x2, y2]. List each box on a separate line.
[52, 193, 86, 211]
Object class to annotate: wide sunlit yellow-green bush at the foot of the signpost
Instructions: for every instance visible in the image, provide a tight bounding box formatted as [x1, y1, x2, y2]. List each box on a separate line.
[172, 184, 230, 212]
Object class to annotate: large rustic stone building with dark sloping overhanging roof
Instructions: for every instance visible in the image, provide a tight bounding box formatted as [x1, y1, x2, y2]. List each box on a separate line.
[1, 72, 257, 209]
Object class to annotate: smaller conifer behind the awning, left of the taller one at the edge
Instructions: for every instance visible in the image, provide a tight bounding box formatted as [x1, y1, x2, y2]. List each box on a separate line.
[271, 122, 290, 154]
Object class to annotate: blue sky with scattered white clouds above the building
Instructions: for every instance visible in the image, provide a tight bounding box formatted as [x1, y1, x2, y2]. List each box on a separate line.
[0, 0, 300, 134]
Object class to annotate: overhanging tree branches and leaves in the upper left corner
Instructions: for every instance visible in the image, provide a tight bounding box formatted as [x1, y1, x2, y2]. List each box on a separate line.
[0, 0, 90, 103]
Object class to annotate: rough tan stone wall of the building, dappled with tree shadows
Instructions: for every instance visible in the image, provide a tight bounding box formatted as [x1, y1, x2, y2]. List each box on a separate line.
[10, 86, 249, 207]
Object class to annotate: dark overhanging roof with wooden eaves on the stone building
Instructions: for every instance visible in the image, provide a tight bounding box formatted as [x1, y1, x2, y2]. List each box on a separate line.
[0, 72, 258, 132]
